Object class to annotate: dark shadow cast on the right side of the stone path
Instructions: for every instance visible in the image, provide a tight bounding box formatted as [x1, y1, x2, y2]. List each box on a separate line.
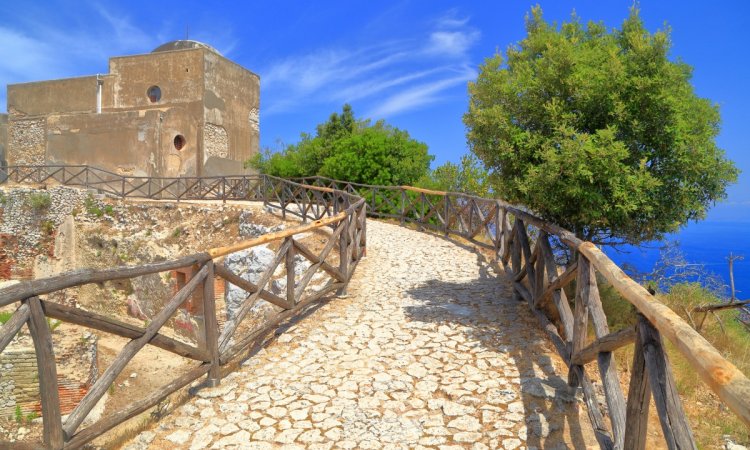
[404, 270, 591, 449]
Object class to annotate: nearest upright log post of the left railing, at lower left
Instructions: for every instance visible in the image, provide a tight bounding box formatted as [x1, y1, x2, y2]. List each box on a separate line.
[26, 297, 65, 450]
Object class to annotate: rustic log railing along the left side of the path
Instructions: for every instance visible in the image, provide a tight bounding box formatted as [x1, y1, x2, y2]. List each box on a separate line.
[0, 171, 366, 449]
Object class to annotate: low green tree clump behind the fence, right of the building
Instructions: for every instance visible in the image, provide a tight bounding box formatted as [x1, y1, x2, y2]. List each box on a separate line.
[249, 105, 433, 185]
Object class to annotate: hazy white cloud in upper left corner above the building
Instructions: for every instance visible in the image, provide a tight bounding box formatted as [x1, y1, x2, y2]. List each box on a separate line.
[0, 2, 236, 111]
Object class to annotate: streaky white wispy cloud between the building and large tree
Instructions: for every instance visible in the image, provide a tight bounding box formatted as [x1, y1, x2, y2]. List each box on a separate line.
[260, 11, 480, 119]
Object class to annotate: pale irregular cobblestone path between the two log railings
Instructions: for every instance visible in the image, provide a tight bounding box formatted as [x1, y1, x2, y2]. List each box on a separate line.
[125, 221, 595, 450]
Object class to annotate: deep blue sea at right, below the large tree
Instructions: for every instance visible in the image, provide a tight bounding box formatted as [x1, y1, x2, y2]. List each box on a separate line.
[604, 220, 750, 300]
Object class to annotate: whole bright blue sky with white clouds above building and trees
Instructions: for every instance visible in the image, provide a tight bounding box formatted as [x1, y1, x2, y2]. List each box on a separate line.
[0, 0, 750, 222]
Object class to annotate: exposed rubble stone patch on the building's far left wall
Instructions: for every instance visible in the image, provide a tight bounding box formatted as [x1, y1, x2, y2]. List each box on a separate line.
[7, 118, 47, 165]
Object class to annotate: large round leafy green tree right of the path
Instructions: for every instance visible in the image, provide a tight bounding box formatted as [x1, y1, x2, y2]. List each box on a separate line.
[464, 6, 738, 244]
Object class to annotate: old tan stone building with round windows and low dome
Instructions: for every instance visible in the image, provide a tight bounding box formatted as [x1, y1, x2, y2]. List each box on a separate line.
[0, 40, 260, 177]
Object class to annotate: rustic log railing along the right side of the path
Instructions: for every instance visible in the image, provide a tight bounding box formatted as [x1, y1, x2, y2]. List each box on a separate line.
[300, 177, 750, 449]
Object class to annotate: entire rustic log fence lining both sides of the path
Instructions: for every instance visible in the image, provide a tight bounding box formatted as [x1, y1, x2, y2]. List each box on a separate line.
[0, 166, 750, 449]
